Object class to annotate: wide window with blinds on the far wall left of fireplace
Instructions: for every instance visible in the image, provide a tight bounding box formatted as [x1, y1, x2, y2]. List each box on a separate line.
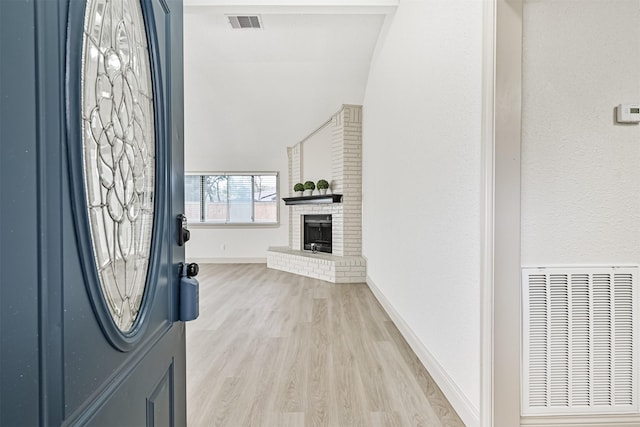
[184, 172, 279, 225]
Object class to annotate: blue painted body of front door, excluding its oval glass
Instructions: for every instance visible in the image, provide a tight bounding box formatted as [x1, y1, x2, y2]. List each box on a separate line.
[0, 0, 186, 426]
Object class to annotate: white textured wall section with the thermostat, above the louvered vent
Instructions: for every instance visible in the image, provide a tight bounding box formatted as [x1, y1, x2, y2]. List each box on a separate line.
[522, 0, 640, 266]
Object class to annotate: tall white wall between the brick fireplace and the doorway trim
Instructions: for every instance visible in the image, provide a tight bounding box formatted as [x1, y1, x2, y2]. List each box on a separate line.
[363, 0, 482, 426]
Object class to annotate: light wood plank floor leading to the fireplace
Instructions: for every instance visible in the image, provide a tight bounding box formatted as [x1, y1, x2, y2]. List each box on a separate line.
[187, 264, 464, 427]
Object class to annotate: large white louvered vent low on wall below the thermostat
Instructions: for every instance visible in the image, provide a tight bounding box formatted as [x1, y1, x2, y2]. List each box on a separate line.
[522, 267, 638, 416]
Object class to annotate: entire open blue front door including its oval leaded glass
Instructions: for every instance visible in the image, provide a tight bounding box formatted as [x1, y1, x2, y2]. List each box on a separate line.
[0, 0, 186, 426]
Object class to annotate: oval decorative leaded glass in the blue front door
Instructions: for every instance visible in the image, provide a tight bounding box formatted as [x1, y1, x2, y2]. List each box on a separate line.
[82, 0, 155, 332]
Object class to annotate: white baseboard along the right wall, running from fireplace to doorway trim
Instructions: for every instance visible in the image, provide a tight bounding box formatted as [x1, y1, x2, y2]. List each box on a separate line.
[366, 276, 480, 427]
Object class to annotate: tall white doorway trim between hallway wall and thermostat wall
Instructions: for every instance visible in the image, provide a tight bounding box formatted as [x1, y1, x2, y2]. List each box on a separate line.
[480, 0, 523, 427]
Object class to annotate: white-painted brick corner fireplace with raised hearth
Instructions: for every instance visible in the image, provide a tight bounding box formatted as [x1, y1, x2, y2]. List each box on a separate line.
[267, 105, 366, 283]
